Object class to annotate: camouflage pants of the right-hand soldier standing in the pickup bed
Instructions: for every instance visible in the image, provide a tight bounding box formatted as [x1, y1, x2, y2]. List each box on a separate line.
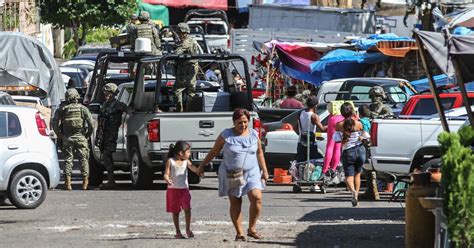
[174, 64, 198, 112]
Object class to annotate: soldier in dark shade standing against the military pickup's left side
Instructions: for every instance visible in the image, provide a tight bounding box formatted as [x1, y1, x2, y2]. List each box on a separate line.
[95, 83, 127, 187]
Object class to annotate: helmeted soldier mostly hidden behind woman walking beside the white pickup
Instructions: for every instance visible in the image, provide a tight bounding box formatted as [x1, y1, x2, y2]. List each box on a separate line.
[363, 86, 393, 200]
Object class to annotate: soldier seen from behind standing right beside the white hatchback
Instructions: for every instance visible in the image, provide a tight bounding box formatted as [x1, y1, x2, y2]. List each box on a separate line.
[53, 89, 93, 190]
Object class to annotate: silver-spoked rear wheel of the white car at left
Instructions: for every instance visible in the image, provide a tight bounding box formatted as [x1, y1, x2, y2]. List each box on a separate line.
[8, 170, 48, 209]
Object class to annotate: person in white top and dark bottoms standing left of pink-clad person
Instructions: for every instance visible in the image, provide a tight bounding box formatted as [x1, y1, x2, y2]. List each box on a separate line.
[296, 96, 327, 162]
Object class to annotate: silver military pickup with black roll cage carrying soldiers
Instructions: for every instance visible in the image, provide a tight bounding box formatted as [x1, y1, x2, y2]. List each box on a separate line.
[89, 54, 261, 189]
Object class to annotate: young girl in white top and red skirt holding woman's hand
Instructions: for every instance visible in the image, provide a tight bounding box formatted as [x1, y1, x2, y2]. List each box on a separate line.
[163, 140, 199, 239]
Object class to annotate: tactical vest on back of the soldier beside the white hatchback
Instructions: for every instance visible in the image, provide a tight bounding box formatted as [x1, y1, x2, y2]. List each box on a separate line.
[61, 103, 84, 136]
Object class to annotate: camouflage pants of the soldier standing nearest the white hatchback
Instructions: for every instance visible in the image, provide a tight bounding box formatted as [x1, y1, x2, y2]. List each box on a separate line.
[63, 137, 89, 177]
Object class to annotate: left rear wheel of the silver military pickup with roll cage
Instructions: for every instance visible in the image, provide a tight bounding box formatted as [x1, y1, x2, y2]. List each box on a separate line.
[130, 147, 154, 189]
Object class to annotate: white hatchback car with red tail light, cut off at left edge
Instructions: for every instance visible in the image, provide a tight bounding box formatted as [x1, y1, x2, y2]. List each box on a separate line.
[0, 105, 60, 209]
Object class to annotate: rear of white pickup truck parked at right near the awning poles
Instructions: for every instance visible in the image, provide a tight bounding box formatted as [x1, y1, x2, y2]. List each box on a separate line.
[366, 119, 465, 176]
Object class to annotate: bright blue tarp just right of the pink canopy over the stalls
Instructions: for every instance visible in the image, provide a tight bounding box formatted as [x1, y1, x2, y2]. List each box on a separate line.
[310, 49, 388, 83]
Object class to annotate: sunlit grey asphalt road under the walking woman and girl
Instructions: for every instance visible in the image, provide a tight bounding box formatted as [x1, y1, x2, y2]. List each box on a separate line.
[0, 170, 405, 248]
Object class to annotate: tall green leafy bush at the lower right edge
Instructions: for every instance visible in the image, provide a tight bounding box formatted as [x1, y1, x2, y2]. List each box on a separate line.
[438, 129, 474, 247]
